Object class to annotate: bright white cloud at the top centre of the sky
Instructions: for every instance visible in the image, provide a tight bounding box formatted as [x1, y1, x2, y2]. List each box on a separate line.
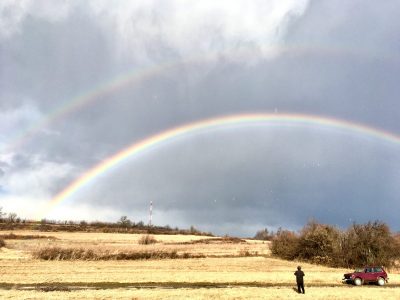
[87, 0, 308, 59]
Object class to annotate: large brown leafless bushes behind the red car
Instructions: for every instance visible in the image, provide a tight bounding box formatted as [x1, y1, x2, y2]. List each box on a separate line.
[271, 221, 400, 268]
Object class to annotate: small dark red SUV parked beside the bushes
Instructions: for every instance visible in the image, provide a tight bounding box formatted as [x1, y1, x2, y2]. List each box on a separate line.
[343, 267, 389, 286]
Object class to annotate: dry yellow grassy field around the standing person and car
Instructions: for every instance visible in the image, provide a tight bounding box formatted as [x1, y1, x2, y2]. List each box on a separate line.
[0, 231, 400, 299]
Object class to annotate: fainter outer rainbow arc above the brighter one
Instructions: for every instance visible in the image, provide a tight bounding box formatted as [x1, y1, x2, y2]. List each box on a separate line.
[0, 45, 387, 151]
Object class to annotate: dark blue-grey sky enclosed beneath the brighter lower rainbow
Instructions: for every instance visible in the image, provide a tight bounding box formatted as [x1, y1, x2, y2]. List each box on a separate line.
[69, 128, 400, 234]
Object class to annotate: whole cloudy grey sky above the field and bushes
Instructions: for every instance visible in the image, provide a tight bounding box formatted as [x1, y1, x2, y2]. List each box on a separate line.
[0, 0, 400, 236]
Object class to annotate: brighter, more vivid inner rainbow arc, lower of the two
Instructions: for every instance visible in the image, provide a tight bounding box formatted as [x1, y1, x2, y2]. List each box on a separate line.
[39, 113, 400, 218]
